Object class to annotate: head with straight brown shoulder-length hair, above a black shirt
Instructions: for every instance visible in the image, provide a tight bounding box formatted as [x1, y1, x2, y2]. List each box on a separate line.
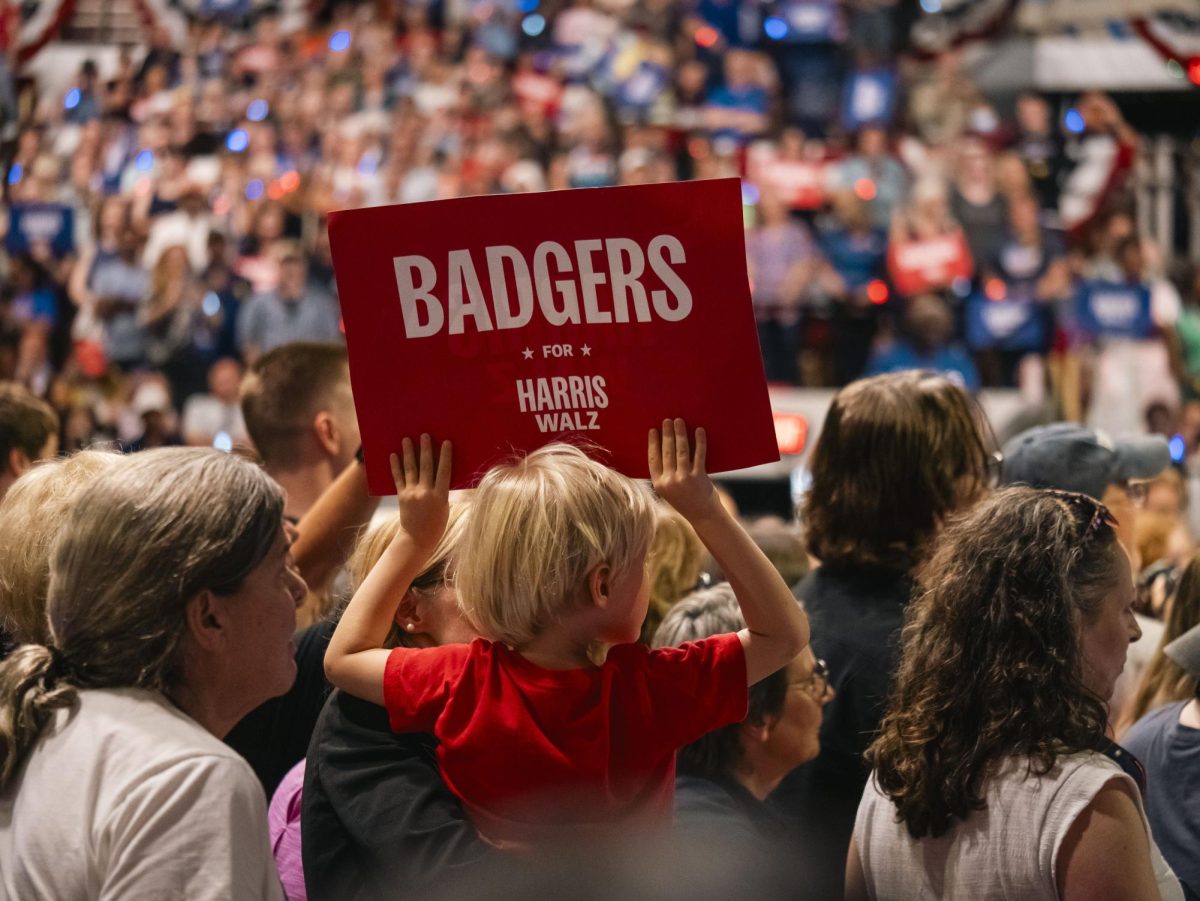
[800, 372, 992, 570]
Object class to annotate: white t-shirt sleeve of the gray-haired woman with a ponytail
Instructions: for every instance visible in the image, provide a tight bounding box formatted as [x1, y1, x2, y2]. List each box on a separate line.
[97, 755, 283, 901]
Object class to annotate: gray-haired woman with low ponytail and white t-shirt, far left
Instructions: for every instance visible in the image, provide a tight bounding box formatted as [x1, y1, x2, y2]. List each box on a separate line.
[0, 449, 306, 901]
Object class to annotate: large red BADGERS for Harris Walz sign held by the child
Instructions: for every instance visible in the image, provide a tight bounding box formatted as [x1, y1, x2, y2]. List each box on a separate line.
[329, 179, 779, 494]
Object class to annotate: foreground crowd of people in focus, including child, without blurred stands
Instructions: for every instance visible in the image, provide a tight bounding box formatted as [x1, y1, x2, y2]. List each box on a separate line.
[0, 355, 1200, 901]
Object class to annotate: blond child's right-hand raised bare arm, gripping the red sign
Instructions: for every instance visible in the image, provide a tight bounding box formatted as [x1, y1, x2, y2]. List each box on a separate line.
[649, 419, 809, 685]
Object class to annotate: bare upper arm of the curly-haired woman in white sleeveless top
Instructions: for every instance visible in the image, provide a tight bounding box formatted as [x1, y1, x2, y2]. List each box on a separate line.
[1056, 779, 1159, 901]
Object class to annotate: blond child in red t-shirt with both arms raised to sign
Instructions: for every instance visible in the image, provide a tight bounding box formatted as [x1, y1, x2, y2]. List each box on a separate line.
[325, 420, 808, 847]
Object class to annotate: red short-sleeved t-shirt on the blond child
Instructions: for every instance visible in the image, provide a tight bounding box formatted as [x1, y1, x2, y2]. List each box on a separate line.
[383, 633, 749, 846]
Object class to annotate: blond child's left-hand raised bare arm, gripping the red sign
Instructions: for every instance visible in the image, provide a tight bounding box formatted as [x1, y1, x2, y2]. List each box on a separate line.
[325, 434, 450, 704]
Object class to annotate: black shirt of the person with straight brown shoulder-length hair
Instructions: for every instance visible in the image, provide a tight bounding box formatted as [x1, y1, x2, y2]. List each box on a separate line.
[770, 564, 912, 899]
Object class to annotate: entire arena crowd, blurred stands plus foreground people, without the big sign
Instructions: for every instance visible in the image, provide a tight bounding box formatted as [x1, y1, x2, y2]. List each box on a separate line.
[0, 0, 1200, 901]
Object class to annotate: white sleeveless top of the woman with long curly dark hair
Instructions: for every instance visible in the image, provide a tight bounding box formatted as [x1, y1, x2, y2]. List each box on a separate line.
[854, 753, 1183, 901]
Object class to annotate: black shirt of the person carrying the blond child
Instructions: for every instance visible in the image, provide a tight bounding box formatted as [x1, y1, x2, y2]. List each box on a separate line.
[300, 691, 489, 901]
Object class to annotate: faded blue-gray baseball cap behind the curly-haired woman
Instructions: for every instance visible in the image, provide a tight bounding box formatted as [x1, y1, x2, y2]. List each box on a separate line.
[1000, 422, 1171, 499]
